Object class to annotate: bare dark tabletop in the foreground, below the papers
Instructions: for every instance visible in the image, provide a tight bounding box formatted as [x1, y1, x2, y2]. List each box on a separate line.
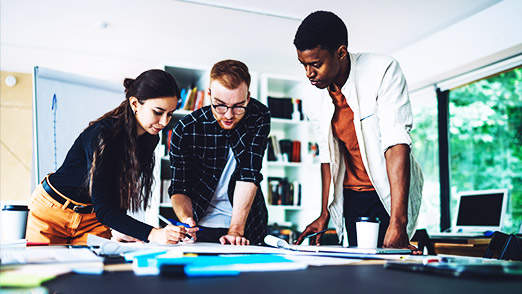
[44, 265, 522, 294]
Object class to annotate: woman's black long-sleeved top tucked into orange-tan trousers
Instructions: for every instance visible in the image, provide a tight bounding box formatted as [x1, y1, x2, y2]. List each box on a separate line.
[49, 118, 155, 241]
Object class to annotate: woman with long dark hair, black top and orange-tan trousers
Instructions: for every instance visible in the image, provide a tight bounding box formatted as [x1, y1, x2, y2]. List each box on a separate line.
[27, 69, 186, 244]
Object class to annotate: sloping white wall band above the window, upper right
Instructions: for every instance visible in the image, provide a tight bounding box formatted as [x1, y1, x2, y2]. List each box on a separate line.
[392, 0, 522, 90]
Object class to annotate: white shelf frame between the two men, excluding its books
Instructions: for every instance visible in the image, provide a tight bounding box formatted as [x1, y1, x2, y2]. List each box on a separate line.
[259, 74, 321, 230]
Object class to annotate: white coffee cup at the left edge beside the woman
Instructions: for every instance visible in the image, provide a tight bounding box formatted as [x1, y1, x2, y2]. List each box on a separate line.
[0, 205, 29, 241]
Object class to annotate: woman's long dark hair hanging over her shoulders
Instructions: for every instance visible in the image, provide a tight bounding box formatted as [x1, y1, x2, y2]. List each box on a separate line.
[88, 69, 180, 211]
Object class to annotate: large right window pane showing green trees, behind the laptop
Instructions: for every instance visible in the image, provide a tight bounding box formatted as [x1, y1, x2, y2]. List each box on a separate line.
[446, 67, 522, 233]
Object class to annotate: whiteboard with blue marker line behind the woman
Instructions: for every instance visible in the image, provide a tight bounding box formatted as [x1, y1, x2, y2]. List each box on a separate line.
[31, 66, 125, 186]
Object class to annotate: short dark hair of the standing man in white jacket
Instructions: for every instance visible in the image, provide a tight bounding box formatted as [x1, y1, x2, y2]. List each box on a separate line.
[294, 11, 348, 52]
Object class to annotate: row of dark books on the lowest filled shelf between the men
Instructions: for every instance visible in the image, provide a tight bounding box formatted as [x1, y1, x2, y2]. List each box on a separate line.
[268, 177, 301, 206]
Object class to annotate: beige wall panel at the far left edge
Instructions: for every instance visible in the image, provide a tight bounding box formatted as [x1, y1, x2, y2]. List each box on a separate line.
[0, 71, 33, 201]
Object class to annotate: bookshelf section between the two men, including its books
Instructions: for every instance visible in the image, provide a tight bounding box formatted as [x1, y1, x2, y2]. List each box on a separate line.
[259, 74, 321, 230]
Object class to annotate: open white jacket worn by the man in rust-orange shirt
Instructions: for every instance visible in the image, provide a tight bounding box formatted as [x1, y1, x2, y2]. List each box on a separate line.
[303, 53, 424, 240]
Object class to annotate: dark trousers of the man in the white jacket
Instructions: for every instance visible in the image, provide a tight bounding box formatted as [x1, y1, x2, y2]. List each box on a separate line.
[343, 189, 390, 247]
